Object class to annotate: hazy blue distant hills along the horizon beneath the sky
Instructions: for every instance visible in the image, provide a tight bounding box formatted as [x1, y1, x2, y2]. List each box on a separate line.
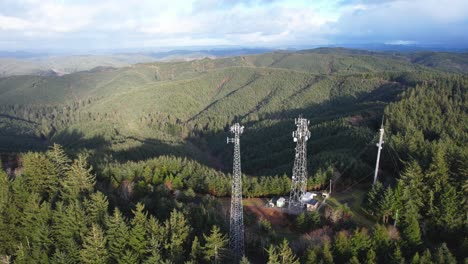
[0, 47, 468, 77]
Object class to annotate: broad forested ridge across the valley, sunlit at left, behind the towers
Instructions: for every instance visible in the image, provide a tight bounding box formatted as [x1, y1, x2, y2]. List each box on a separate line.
[0, 49, 462, 175]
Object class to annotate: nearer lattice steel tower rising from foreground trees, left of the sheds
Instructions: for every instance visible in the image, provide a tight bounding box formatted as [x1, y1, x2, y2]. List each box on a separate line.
[227, 123, 244, 259]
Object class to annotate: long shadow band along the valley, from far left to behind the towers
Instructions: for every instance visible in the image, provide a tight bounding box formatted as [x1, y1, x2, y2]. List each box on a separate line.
[0, 80, 404, 179]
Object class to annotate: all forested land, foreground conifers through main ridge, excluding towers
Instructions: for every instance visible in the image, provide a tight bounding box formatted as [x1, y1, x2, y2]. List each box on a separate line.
[0, 49, 468, 263]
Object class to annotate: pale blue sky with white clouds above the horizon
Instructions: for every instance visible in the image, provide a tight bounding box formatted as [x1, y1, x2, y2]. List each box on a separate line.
[0, 0, 468, 50]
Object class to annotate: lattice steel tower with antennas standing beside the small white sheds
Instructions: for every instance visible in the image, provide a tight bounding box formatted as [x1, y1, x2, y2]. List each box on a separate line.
[288, 117, 310, 211]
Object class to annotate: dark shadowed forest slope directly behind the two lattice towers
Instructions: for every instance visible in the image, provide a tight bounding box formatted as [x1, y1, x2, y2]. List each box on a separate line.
[190, 83, 405, 178]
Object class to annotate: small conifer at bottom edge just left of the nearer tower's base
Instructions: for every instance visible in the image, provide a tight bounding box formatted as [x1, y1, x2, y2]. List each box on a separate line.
[203, 225, 228, 263]
